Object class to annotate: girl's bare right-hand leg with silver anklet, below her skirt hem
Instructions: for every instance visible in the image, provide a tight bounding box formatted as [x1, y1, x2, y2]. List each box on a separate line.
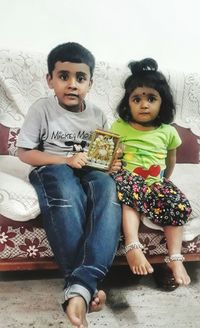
[164, 226, 190, 285]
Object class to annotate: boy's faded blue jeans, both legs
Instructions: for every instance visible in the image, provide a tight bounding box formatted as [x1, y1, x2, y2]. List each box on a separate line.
[30, 164, 121, 302]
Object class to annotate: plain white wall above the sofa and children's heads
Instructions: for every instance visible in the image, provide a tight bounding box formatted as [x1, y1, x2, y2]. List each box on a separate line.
[0, 0, 200, 72]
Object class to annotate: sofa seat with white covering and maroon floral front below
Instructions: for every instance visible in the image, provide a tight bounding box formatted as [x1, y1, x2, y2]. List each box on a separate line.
[0, 155, 200, 270]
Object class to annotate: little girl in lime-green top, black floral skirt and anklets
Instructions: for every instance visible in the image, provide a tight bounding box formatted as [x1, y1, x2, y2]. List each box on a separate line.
[111, 58, 191, 285]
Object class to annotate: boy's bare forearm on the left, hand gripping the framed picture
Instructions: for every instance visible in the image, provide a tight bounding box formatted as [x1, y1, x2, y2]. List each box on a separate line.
[18, 147, 87, 169]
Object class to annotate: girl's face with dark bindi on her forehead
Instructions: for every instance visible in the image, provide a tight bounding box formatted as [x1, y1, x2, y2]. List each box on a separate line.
[129, 87, 162, 127]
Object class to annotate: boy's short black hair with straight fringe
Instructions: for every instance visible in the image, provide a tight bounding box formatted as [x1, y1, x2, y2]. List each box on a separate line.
[47, 42, 95, 78]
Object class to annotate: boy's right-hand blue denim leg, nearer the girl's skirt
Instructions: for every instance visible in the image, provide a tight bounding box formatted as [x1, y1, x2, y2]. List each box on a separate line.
[65, 170, 121, 302]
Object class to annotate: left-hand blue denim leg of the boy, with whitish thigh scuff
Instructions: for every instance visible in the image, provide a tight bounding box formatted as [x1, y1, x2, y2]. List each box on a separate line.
[30, 164, 87, 278]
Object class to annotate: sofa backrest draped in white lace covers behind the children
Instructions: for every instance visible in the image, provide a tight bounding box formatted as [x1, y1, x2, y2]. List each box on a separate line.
[0, 49, 200, 163]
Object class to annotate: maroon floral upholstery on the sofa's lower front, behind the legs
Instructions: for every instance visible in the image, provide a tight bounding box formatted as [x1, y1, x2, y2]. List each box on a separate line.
[0, 215, 200, 270]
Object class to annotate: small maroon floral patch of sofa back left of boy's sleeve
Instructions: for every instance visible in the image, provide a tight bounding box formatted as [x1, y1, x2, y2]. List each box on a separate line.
[0, 123, 19, 156]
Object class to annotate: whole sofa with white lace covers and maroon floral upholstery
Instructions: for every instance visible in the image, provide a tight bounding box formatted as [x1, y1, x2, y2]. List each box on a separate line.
[0, 49, 200, 284]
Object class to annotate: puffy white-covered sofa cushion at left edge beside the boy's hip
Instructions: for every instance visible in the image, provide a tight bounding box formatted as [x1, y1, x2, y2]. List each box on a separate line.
[0, 155, 40, 221]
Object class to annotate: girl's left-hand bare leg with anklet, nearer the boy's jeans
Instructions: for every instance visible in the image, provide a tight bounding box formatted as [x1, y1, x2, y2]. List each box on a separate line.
[123, 204, 153, 275]
